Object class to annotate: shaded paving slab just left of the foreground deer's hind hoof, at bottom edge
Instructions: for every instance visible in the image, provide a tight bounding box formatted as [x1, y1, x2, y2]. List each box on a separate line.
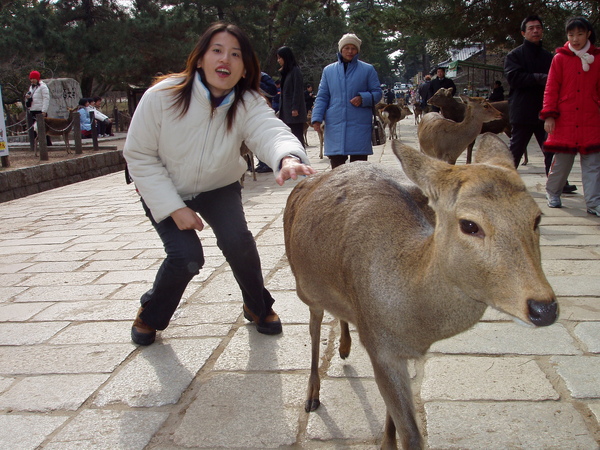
[173, 373, 306, 448]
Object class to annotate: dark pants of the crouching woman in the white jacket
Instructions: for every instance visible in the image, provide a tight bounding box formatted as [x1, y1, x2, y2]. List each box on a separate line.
[140, 182, 275, 330]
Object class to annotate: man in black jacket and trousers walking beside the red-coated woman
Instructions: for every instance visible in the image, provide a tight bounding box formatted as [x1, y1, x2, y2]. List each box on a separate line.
[504, 14, 577, 193]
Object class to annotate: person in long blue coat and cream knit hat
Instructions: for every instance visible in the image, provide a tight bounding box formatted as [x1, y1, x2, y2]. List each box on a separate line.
[312, 33, 383, 169]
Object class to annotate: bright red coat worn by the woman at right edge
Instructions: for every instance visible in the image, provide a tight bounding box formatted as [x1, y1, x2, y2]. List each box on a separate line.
[540, 42, 600, 154]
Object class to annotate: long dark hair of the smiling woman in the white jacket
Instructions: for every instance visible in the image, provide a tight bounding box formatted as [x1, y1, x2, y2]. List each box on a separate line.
[157, 22, 260, 130]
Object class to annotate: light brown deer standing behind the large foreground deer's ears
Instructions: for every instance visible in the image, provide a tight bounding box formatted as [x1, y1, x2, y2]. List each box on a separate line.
[417, 95, 502, 164]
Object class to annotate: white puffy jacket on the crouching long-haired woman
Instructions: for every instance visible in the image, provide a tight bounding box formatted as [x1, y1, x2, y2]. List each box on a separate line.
[123, 76, 309, 222]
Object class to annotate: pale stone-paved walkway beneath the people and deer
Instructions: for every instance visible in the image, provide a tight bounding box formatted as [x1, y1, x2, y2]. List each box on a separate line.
[0, 116, 600, 450]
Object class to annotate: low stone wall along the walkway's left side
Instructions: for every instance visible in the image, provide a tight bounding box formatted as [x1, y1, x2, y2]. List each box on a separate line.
[0, 150, 125, 202]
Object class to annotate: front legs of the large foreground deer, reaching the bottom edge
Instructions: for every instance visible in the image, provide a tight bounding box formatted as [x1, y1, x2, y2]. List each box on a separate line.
[368, 354, 422, 449]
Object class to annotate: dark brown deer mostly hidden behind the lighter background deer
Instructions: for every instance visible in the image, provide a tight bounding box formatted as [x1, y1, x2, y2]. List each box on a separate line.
[428, 88, 516, 165]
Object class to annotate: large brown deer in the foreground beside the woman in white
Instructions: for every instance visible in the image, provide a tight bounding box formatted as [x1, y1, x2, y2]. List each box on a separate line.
[284, 133, 558, 449]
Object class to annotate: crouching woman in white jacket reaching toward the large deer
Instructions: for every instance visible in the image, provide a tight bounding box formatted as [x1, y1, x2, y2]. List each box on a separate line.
[124, 23, 315, 345]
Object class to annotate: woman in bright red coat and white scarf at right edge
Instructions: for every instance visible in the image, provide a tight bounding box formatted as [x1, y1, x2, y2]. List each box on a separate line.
[540, 17, 600, 216]
